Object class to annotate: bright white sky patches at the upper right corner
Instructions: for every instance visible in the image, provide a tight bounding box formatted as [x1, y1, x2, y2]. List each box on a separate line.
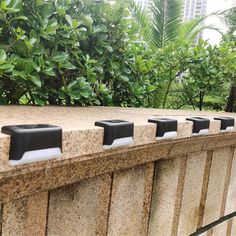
[203, 0, 236, 44]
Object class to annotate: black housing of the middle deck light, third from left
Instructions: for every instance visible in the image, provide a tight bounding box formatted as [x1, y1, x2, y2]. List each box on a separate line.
[148, 118, 178, 137]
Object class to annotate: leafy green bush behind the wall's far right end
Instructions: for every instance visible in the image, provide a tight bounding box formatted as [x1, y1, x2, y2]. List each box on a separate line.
[169, 40, 236, 110]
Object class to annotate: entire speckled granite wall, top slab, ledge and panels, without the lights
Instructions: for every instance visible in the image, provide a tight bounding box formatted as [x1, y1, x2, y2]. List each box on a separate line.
[0, 106, 236, 236]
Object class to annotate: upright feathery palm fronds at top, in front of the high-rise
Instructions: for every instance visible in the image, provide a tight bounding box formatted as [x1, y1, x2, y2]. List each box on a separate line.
[130, 0, 182, 47]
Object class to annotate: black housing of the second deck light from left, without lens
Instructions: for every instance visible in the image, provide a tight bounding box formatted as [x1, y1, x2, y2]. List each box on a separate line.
[95, 120, 134, 145]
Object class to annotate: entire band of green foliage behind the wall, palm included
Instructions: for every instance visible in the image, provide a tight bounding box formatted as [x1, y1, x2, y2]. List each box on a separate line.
[0, 0, 236, 109]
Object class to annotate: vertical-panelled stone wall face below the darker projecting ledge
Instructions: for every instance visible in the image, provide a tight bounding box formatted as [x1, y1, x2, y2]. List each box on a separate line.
[1, 146, 236, 236]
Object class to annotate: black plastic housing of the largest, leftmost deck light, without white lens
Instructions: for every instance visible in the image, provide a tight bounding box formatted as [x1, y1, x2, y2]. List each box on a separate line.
[2, 124, 62, 160]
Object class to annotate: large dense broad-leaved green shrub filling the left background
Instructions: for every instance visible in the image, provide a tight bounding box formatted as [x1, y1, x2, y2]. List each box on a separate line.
[0, 0, 157, 106]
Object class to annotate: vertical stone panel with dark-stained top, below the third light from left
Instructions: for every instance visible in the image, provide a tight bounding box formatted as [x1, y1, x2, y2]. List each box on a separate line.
[149, 158, 185, 236]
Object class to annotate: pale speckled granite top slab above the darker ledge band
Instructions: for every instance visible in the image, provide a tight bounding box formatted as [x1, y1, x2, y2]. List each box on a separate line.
[0, 106, 234, 174]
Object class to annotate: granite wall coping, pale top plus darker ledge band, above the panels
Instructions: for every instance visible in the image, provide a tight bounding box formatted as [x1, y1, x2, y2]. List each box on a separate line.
[0, 106, 236, 201]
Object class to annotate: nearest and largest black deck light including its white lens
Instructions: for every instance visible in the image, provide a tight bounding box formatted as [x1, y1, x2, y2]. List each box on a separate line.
[2, 124, 62, 165]
